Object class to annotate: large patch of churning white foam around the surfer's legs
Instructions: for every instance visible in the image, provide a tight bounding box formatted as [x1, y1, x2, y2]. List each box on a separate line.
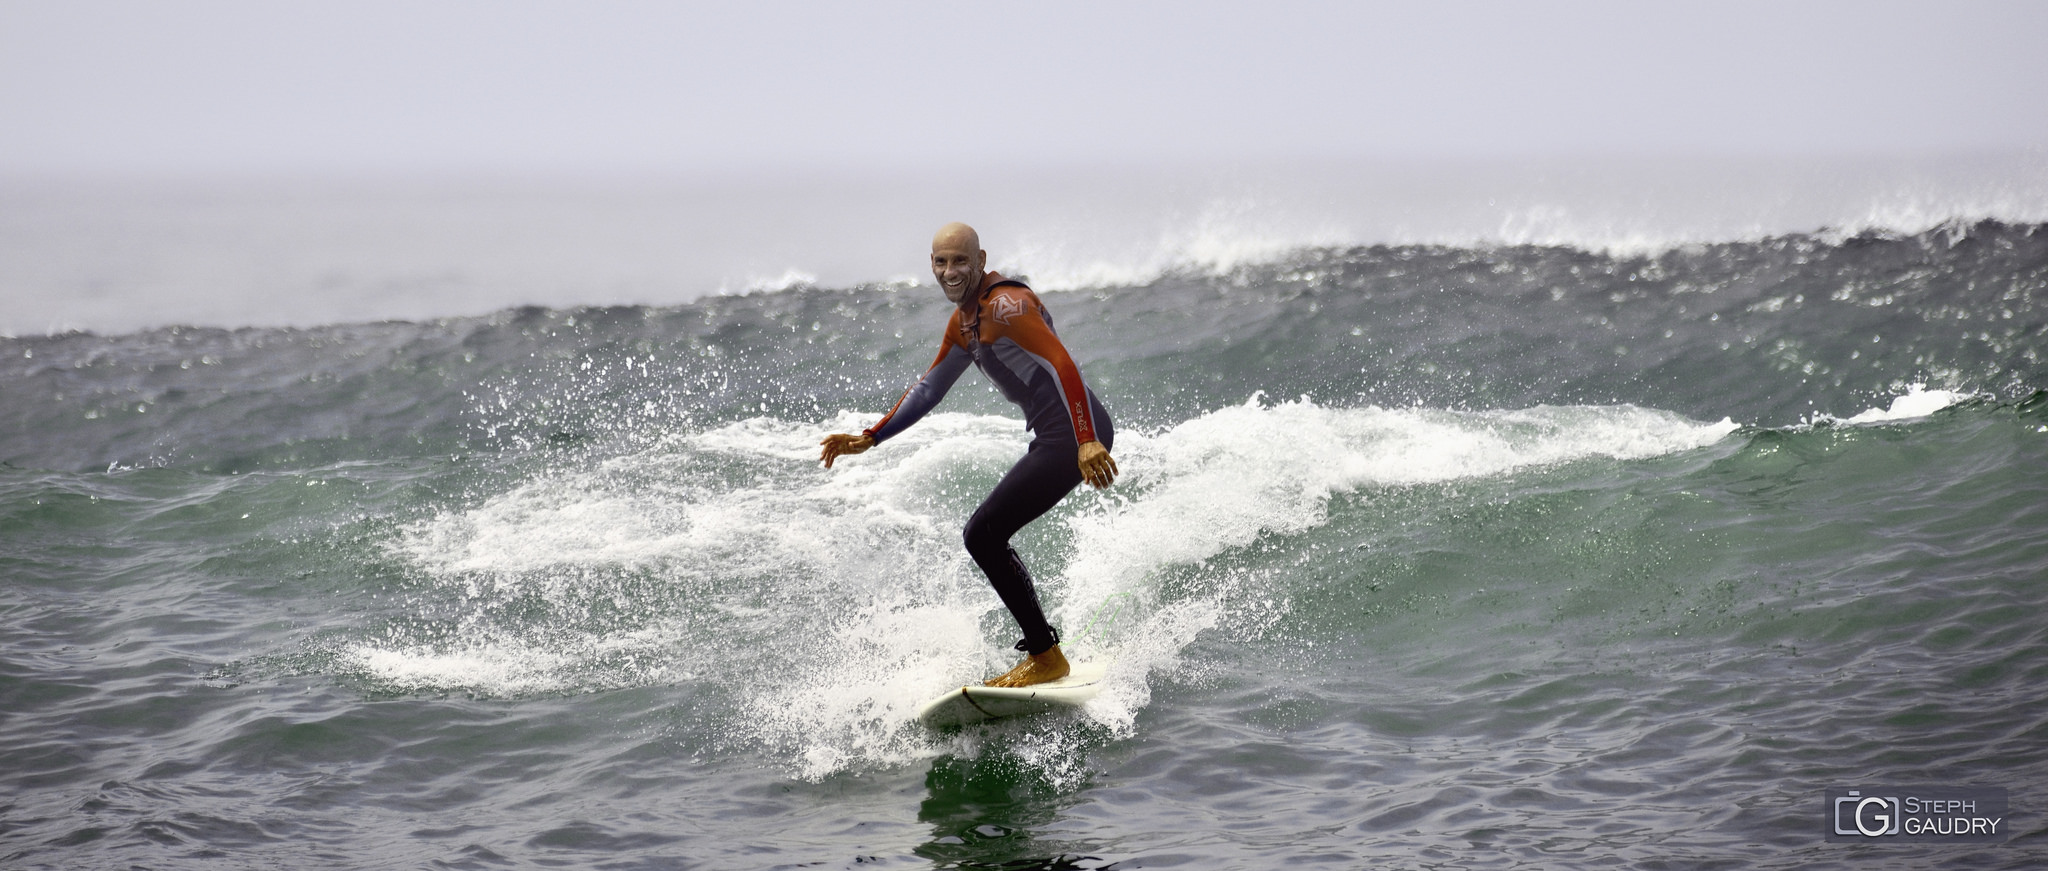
[376, 398, 1735, 779]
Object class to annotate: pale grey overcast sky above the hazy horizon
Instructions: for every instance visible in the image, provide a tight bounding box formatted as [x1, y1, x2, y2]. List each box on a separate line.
[0, 0, 2048, 176]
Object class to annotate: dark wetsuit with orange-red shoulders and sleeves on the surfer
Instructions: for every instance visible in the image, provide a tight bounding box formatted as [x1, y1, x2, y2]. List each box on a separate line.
[864, 273, 1116, 654]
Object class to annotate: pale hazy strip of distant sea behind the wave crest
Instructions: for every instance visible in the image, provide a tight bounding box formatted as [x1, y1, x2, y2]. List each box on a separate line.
[12, 156, 2048, 334]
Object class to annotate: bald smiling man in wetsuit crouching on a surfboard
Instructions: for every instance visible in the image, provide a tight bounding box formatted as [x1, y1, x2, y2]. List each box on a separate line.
[819, 223, 1116, 687]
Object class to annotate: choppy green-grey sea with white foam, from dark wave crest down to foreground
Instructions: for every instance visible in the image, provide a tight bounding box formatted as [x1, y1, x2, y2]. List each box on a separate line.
[0, 199, 2048, 869]
